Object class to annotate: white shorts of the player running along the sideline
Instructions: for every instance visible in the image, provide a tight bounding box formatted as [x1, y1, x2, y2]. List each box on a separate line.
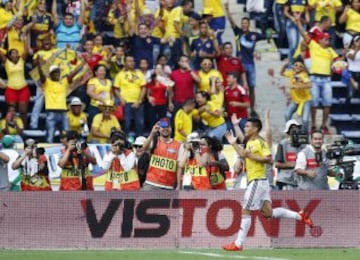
[243, 178, 271, 210]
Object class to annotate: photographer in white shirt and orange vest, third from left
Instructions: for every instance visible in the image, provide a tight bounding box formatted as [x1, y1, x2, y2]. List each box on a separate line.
[103, 131, 140, 191]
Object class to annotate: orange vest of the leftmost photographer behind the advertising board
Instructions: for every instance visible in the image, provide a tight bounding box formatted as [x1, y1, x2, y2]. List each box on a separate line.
[20, 156, 52, 191]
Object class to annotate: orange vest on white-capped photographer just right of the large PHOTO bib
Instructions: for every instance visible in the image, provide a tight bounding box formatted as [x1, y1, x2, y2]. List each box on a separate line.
[183, 158, 211, 190]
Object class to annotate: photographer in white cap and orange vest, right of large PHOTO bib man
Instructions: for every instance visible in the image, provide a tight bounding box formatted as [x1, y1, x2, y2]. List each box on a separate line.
[179, 132, 211, 190]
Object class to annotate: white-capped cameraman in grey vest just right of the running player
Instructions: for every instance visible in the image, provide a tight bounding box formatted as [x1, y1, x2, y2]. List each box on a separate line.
[275, 119, 303, 190]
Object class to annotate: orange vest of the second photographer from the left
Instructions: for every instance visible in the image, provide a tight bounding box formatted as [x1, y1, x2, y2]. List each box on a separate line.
[60, 148, 94, 191]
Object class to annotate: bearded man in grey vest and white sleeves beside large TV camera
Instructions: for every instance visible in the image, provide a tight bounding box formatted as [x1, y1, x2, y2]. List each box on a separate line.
[295, 130, 336, 190]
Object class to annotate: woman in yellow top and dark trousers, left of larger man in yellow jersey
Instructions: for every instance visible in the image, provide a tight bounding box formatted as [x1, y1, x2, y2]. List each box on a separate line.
[86, 64, 113, 125]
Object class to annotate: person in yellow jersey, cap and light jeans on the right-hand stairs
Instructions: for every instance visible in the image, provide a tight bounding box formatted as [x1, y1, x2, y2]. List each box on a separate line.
[280, 60, 312, 133]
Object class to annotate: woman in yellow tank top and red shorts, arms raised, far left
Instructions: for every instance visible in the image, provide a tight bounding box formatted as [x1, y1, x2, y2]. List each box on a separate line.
[0, 43, 30, 125]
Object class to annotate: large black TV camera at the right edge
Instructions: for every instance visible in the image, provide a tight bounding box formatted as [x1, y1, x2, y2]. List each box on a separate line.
[326, 139, 360, 190]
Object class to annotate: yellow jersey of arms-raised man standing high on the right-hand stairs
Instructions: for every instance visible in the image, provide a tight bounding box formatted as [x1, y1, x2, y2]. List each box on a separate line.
[309, 40, 339, 76]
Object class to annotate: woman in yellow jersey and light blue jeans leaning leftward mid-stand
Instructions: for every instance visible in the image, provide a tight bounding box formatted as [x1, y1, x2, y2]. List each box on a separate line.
[196, 91, 227, 140]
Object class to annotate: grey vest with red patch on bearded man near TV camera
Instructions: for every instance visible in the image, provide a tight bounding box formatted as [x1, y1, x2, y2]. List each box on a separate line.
[298, 145, 329, 190]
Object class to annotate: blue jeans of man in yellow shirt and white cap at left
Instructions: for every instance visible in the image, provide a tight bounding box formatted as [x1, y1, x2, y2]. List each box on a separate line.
[46, 112, 69, 143]
